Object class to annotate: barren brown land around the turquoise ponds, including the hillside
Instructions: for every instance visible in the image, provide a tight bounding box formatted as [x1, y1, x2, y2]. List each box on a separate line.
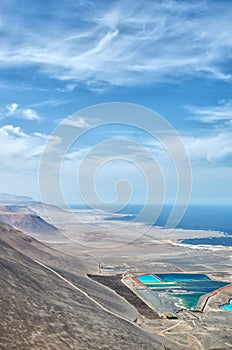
[0, 203, 232, 350]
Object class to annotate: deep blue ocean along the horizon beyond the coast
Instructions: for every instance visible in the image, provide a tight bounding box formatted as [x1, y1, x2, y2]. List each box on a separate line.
[70, 204, 232, 246]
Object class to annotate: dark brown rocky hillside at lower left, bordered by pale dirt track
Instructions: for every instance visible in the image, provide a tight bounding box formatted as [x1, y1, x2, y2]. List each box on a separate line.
[0, 223, 165, 350]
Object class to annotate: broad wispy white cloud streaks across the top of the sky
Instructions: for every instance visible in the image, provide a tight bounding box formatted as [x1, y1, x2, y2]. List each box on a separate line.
[0, 0, 232, 87]
